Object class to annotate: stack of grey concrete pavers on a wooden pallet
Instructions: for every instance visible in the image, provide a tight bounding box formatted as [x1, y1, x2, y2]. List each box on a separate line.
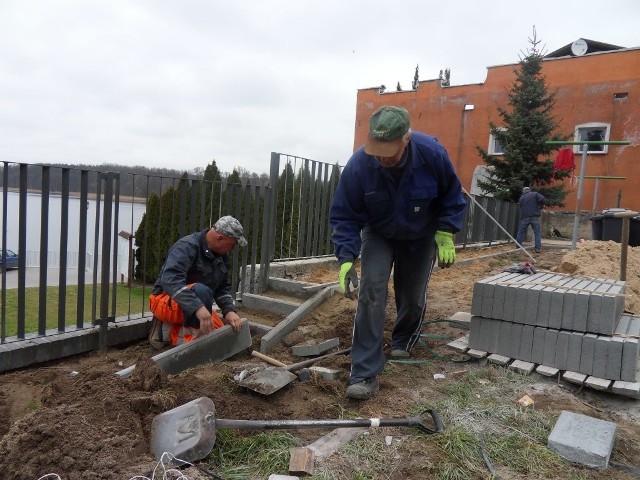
[469, 272, 640, 382]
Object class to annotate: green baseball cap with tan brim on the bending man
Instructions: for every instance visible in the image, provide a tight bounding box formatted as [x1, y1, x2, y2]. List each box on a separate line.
[364, 106, 410, 157]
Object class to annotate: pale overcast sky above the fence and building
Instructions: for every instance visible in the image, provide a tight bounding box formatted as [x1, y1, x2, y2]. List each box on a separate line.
[0, 0, 640, 173]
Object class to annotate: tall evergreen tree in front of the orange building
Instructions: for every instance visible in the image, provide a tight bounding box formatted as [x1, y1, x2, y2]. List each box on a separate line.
[476, 28, 570, 206]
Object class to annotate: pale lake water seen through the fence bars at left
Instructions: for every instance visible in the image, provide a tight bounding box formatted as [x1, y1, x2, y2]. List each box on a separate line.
[0, 189, 146, 274]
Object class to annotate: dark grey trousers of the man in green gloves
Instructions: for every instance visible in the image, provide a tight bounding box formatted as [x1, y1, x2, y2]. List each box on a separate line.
[349, 227, 436, 384]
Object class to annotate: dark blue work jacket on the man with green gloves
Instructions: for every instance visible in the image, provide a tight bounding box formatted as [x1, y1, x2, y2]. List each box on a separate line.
[330, 132, 467, 262]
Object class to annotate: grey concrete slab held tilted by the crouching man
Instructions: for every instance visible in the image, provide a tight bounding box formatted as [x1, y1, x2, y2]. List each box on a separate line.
[152, 318, 251, 375]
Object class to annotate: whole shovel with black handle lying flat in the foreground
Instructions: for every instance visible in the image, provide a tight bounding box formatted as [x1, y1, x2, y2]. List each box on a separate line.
[151, 397, 444, 463]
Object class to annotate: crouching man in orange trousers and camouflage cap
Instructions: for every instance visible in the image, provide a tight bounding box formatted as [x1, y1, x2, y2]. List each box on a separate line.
[149, 215, 247, 349]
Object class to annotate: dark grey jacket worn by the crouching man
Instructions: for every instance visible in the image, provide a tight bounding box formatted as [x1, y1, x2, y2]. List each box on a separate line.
[151, 229, 236, 317]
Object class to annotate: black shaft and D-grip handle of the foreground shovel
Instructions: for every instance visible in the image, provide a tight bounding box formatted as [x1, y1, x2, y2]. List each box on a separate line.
[216, 409, 444, 434]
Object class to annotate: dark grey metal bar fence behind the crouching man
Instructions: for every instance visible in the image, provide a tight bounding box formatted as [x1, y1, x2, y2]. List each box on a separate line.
[0, 153, 517, 371]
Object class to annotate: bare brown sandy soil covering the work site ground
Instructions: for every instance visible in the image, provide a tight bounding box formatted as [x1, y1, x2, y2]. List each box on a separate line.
[0, 242, 640, 480]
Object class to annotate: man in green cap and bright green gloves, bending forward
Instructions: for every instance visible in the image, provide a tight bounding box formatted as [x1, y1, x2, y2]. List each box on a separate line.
[330, 106, 466, 400]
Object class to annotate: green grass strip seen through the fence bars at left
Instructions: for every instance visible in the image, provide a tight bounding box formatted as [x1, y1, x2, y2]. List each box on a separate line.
[0, 284, 151, 337]
